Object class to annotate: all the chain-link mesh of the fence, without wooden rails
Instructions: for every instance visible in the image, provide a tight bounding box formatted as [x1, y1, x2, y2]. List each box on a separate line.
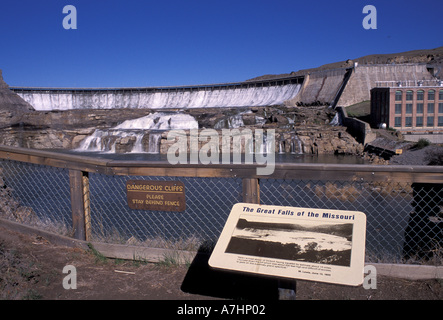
[0, 156, 443, 264]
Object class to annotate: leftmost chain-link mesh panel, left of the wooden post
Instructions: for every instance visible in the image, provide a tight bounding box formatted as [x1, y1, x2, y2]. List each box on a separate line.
[0, 160, 72, 236]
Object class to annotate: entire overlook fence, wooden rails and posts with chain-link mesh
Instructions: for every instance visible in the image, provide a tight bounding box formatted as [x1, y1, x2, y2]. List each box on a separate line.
[0, 147, 443, 263]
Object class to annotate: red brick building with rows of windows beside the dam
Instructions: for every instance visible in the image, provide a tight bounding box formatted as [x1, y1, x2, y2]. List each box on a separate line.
[371, 81, 443, 143]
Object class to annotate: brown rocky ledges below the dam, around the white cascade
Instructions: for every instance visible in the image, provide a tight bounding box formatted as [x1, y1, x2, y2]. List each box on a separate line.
[0, 106, 363, 155]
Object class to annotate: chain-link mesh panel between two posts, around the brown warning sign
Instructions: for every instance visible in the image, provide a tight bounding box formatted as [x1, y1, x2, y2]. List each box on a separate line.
[89, 174, 242, 249]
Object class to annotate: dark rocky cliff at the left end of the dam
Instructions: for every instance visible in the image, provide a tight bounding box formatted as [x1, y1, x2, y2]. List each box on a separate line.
[0, 70, 34, 128]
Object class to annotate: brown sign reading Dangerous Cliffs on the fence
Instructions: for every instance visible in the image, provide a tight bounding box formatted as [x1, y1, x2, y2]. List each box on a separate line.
[126, 180, 186, 212]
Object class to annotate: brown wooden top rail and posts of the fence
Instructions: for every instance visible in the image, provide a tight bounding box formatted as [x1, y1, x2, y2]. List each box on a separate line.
[0, 146, 443, 240]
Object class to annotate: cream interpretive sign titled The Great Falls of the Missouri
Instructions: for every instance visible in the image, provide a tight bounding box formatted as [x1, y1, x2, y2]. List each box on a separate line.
[209, 203, 366, 286]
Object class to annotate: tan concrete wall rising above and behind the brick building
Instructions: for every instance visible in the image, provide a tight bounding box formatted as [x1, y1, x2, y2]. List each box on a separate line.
[338, 64, 435, 107]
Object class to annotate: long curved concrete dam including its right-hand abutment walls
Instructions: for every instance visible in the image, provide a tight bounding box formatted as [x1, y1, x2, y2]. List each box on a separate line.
[10, 64, 435, 111]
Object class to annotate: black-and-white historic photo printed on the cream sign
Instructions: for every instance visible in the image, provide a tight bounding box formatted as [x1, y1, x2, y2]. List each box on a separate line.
[225, 216, 353, 267]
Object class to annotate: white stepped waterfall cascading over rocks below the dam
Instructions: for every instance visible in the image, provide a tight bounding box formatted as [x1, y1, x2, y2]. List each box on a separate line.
[76, 112, 198, 153]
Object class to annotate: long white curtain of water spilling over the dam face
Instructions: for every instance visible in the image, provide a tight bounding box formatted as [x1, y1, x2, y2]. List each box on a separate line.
[17, 84, 301, 111]
